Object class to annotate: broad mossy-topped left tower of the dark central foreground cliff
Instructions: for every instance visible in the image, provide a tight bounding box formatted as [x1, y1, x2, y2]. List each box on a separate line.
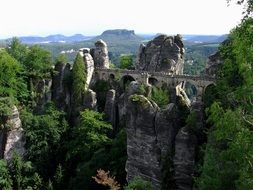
[126, 95, 161, 189]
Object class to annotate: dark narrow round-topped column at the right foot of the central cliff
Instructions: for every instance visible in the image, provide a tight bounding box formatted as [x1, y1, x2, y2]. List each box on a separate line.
[174, 127, 197, 190]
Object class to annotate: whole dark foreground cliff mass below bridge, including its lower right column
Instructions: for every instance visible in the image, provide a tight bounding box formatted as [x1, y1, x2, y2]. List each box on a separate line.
[113, 81, 196, 190]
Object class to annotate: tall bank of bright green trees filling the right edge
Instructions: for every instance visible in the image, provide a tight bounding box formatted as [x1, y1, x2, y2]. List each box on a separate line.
[197, 18, 253, 190]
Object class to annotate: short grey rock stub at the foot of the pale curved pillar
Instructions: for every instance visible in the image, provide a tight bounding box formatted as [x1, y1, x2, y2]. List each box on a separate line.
[82, 89, 97, 110]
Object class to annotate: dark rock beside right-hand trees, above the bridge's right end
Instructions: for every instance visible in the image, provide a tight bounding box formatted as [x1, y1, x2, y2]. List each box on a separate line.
[205, 52, 223, 77]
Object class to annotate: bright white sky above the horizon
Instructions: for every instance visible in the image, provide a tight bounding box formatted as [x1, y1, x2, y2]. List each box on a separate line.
[0, 0, 245, 39]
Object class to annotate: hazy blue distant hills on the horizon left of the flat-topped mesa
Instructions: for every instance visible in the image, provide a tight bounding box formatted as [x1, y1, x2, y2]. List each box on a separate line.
[3, 34, 92, 44]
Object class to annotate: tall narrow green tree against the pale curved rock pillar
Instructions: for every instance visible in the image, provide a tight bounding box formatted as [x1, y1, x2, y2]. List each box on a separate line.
[73, 53, 87, 103]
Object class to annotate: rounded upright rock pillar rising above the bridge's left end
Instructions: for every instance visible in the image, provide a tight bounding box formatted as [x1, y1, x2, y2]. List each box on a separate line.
[91, 40, 109, 69]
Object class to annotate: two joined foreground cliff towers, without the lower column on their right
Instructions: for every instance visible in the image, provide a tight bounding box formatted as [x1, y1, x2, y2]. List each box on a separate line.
[125, 81, 190, 190]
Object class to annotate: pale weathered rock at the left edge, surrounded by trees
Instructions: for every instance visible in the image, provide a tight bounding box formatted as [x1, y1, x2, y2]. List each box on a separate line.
[0, 106, 25, 162]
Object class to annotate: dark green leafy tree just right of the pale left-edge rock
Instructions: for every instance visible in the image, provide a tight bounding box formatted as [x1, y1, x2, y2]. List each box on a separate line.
[21, 103, 68, 179]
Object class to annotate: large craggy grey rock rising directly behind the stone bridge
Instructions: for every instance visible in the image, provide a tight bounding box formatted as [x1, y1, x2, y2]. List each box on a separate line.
[136, 35, 185, 75]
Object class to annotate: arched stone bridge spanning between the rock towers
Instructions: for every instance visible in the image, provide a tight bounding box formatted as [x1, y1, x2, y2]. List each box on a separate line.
[95, 68, 215, 99]
